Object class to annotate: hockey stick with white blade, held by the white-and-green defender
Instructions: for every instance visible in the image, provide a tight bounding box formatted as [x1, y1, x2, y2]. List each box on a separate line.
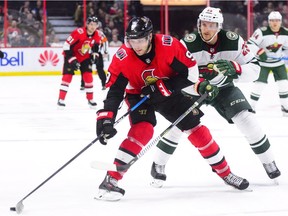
[90, 93, 208, 172]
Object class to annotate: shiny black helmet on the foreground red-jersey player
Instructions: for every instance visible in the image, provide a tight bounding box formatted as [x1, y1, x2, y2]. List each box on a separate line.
[126, 16, 153, 39]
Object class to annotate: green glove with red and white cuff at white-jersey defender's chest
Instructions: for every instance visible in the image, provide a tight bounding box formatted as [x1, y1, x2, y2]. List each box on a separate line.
[213, 59, 242, 79]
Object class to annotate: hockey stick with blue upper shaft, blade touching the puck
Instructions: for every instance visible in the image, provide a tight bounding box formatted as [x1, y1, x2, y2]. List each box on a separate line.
[10, 96, 149, 214]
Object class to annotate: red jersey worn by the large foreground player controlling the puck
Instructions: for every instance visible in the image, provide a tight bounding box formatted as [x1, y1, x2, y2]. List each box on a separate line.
[106, 34, 197, 94]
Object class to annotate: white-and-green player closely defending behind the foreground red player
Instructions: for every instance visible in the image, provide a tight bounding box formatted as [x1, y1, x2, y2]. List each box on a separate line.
[151, 7, 281, 187]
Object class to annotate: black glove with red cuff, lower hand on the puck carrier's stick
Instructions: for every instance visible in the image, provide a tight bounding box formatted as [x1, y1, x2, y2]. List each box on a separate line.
[96, 109, 117, 145]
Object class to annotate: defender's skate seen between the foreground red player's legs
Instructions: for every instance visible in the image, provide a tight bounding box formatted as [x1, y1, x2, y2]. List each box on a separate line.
[150, 162, 167, 188]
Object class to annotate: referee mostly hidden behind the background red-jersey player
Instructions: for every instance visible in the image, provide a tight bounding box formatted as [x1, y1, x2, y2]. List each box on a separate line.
[80, 29, 109, 90]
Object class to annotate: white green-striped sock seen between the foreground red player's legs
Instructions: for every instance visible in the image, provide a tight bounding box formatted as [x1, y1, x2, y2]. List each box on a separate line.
[153, 127, 182, 165]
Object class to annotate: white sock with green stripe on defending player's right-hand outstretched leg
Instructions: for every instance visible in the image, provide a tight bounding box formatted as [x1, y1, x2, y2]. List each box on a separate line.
[232, 110, 274, 163]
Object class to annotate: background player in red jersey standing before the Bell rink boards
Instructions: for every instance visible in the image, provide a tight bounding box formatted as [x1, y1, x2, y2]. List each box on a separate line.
[57, 16, 101, 108]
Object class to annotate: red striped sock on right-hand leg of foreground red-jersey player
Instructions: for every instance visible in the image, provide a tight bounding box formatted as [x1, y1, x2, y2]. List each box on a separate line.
[188, 125, 231, 178]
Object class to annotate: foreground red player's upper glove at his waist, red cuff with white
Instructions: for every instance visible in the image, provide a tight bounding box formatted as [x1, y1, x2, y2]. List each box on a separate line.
[141, 79, 172, 104]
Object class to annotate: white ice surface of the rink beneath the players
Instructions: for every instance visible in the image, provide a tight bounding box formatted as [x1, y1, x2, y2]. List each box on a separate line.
[0, 76, 288, 216]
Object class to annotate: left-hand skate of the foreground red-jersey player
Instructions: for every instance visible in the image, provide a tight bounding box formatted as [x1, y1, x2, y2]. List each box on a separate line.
[95, 174, 125, 201]
